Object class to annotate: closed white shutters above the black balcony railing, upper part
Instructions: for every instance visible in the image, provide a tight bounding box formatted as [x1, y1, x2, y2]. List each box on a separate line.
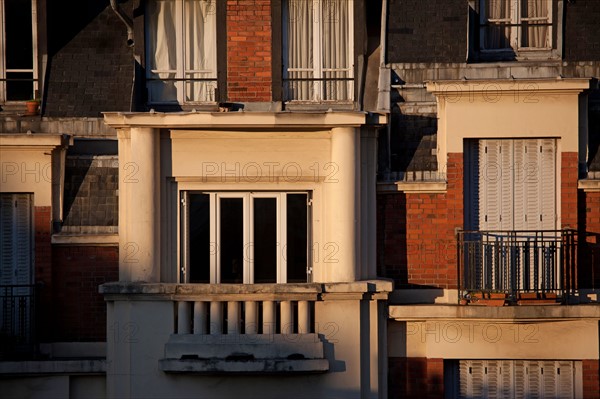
[474, 139, 556, 230]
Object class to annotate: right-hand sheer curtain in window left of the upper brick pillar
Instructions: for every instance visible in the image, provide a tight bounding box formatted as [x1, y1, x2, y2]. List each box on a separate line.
[184, 0, 217, 102]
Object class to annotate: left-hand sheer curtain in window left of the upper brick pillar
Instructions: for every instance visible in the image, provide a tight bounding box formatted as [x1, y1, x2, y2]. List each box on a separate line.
[147, 0, 177, 101]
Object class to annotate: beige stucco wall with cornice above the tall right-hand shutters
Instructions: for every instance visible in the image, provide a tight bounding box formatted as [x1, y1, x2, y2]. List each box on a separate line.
[427, 79, 589, 175]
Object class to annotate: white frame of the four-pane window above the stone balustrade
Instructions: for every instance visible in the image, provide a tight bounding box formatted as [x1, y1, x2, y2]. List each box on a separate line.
[180, 190, 312, 284]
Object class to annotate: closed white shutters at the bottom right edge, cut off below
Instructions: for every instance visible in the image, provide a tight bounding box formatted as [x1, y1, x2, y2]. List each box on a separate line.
[458, 360, 581, 399]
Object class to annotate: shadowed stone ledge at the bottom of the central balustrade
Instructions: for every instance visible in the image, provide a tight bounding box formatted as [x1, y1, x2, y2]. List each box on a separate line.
[158, 359, 329, 375]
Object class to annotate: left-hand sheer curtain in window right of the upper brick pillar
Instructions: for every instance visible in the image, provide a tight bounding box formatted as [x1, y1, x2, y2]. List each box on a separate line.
[284, 0, 315, 101]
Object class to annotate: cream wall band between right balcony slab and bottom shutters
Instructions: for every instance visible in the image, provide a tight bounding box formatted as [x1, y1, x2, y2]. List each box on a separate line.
[388, 319, 599, 360]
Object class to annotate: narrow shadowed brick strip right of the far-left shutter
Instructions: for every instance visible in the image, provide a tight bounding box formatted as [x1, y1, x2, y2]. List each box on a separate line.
[33, 206, 52, 341]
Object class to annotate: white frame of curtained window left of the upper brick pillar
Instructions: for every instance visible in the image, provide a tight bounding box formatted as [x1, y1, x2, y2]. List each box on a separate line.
[146, 0, 218, 104]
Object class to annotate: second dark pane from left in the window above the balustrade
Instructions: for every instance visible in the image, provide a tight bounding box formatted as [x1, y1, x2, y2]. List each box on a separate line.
[218, 198, 244, 284]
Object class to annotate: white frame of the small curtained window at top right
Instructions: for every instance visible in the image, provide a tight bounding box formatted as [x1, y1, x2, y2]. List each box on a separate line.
[479, 0, 560, 55]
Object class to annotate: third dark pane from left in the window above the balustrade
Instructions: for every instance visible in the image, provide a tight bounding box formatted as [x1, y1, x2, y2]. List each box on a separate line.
[253, 198, 277, 283]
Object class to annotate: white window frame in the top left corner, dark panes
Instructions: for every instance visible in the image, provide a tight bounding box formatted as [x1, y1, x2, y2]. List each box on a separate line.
[0, 0, 39, 103]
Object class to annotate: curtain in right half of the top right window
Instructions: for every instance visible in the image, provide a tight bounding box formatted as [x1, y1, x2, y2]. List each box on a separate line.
[521, 0, 550, 48]
